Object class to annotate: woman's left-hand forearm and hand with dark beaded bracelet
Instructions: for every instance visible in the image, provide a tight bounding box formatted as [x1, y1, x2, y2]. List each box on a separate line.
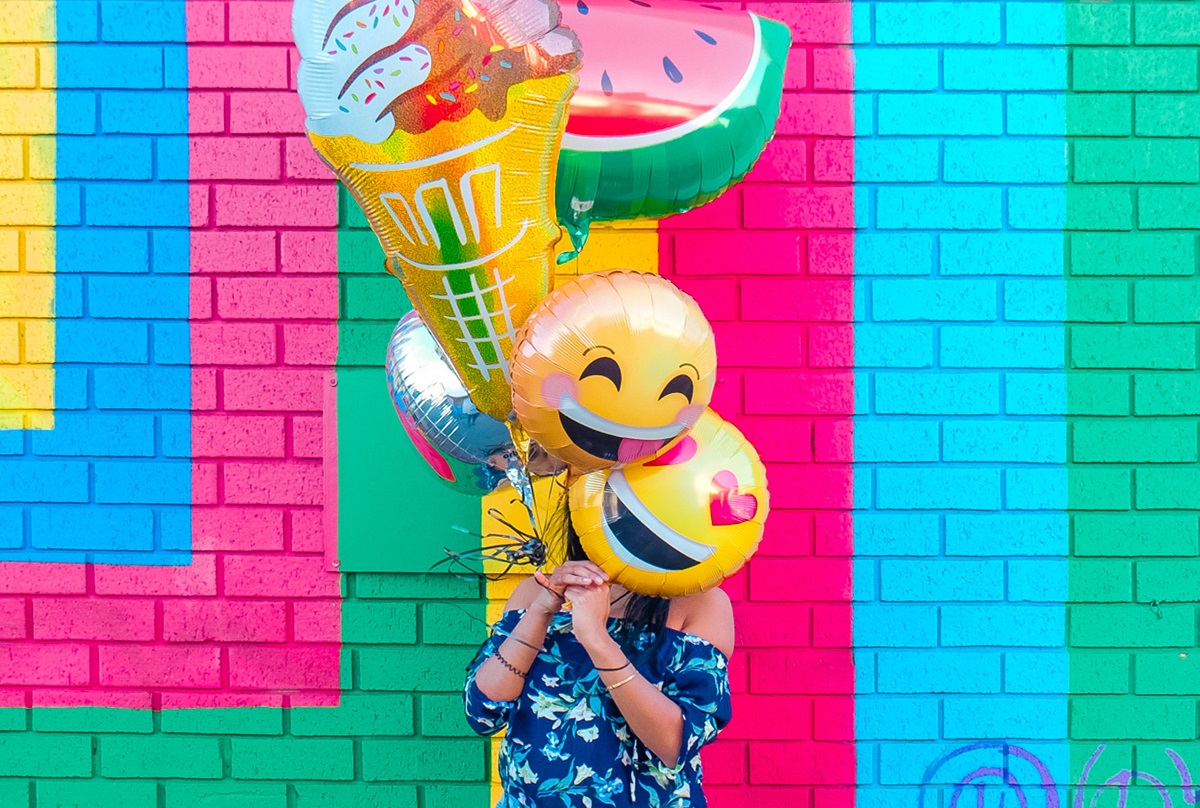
[475, 561, 607, 701]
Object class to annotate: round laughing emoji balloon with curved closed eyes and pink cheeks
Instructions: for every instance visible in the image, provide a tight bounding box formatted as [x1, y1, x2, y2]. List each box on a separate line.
[510, 270, 716, 472]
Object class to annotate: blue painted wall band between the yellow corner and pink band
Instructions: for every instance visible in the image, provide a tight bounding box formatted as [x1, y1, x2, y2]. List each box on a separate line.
[0, 0, 192, 564]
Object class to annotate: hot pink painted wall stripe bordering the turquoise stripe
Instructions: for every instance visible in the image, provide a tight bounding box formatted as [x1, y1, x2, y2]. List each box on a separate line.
[660, 1, 857, 808]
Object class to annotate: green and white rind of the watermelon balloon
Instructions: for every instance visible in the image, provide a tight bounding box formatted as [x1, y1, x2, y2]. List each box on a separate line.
[556, 14, 792, 252]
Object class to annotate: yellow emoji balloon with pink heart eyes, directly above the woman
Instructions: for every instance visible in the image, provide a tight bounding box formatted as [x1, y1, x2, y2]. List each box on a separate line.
[571, 411, 769, 598]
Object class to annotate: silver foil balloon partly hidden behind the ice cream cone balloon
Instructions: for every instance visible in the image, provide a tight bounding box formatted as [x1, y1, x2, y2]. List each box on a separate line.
[386, 312, 516, 493]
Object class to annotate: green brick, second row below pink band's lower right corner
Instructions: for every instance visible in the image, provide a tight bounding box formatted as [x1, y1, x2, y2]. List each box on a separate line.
[229, 738, 354, 780]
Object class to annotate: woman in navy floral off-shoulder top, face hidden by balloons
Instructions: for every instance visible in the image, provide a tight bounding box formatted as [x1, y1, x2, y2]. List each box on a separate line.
[466, 532, 733, 808]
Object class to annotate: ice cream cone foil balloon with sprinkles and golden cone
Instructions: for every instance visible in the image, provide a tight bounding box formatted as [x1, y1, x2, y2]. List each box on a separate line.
[293, 0, 578, 419]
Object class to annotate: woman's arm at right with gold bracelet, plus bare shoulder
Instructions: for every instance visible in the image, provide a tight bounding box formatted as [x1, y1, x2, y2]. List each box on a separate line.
[566, 586, 733, 766]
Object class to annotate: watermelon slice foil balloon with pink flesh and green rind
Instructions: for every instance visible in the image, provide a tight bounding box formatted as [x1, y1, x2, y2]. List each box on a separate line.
[556, 0, 791, 256]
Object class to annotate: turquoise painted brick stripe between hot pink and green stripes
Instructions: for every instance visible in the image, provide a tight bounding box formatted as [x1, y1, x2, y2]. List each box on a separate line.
[853, 2, 1068, 808]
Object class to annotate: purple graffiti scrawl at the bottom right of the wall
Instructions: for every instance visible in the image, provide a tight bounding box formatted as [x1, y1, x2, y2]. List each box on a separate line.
[918, 741, 1198, 808]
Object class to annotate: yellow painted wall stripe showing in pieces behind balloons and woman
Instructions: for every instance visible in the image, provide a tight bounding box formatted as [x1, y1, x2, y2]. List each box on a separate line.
[480, 222, 659, 806]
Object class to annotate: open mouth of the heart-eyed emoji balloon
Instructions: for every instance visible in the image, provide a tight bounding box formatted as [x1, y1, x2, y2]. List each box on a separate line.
[600, 469, 716, 573]
